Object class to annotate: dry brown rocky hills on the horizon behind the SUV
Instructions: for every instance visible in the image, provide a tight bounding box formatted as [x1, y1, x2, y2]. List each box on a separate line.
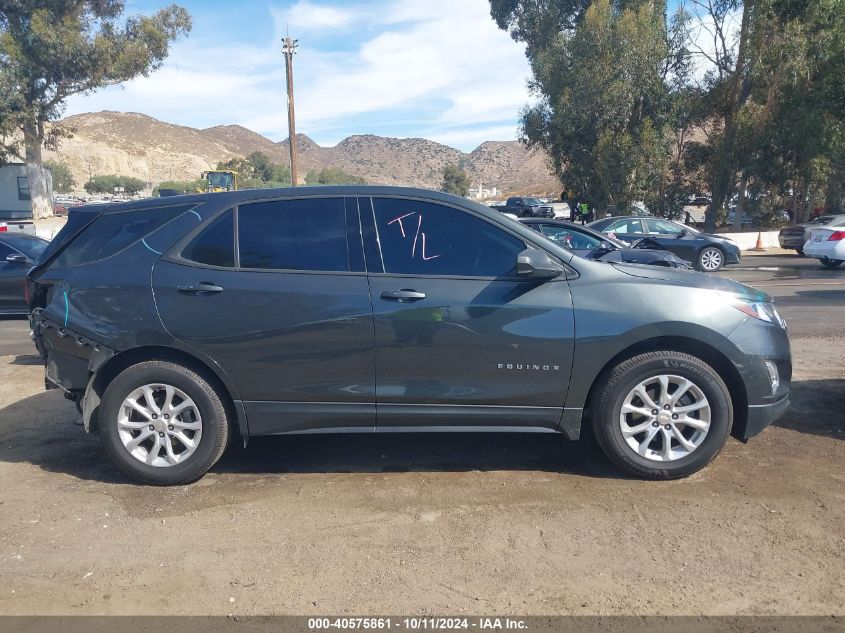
[45, 112, 559, 192]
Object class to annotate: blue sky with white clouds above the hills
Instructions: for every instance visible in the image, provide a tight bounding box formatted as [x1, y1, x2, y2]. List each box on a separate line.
[66, 0, 530, 150]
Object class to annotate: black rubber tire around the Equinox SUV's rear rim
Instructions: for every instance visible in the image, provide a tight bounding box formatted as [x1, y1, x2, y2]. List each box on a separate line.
[98, 361, 229, 485]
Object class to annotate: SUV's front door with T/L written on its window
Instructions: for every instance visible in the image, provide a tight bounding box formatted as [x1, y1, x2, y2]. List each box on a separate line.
[359, 197, 573, 429]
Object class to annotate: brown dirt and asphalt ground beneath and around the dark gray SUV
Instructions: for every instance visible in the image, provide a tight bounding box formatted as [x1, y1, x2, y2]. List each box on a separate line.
[0, 256, 845, 615]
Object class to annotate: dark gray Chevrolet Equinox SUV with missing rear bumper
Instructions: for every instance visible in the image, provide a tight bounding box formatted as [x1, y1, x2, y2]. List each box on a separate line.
[28, 187, 792, 484]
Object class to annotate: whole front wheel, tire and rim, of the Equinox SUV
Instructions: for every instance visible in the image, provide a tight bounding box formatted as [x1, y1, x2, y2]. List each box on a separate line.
[590, 351, 733, 479]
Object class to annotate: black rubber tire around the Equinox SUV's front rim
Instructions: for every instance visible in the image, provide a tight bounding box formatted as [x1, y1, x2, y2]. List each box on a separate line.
[590, 351, 733, 479]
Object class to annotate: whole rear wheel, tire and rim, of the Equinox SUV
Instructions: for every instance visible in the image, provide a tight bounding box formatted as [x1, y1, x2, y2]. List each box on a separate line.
[98, 361, 229, 485]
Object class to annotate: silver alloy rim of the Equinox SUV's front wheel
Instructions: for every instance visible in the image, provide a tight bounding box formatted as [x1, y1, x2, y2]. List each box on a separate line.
[619, 374, 712, 462]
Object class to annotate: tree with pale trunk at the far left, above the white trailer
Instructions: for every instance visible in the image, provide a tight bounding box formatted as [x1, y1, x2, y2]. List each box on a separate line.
[0, 0, 191, 217]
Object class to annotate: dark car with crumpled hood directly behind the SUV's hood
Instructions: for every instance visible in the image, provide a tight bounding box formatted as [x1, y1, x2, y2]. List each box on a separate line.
[520, 218, 689, 269]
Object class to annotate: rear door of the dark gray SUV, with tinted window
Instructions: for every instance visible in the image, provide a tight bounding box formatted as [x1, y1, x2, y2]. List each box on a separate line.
[153, 197, 375, 435]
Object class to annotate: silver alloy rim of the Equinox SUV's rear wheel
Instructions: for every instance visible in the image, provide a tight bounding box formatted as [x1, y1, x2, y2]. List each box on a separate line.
[117, 383, 202, 468]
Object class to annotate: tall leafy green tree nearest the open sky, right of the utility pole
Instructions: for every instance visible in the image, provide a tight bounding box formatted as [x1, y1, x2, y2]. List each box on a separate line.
[504, 0, 685, 212]
